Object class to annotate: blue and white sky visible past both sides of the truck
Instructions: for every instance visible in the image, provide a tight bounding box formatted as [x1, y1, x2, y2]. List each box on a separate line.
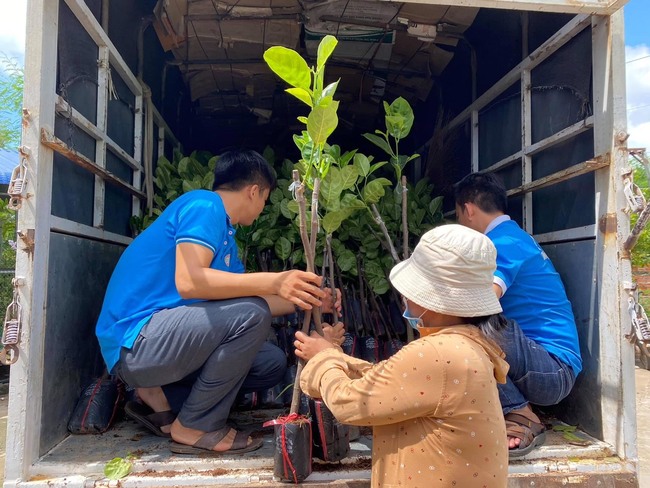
[0, 0, 650, 152]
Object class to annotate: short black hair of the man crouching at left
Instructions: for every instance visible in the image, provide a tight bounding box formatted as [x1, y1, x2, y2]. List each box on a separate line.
[212, 150, 277, 191]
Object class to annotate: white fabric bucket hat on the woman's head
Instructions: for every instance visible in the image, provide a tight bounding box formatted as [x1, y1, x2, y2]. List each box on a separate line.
[390, 224, 502, 317]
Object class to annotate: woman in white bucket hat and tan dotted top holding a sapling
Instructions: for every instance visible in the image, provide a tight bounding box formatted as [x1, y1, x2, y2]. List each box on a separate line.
[295, 224, 508, 487]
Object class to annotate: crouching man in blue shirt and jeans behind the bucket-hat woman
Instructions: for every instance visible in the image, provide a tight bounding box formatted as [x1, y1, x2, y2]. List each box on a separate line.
[454, 173, 582, 458]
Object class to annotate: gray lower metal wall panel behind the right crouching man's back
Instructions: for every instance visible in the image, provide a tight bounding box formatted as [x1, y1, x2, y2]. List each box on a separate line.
[544, 242, 600, 439]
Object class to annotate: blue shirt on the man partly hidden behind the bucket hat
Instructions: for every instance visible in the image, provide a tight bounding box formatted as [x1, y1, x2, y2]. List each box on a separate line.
[486, 220, 582, 375]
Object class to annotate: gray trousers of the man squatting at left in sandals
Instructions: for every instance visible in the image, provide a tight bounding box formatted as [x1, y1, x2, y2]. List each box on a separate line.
[116, 297, 286, 432]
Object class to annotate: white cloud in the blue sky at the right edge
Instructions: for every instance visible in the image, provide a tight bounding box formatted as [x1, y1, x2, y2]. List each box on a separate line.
[625, 44, 650, 150]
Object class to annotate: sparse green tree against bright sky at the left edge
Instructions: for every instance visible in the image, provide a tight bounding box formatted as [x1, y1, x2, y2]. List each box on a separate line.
[0, 56, 24, 149]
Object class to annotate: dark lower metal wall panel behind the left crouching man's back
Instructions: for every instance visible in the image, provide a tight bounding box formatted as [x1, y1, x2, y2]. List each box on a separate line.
[40, 232, 123, 454]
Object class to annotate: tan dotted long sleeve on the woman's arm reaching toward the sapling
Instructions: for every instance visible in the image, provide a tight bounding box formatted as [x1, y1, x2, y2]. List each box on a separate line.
[300, 341, 444, 425]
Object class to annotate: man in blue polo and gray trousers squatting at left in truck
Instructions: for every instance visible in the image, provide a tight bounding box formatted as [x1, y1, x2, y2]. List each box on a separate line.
[96, 151, 343, 454]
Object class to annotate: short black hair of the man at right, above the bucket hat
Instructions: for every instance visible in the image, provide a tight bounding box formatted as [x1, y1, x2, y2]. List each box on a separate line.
[454, 173, 508, 214]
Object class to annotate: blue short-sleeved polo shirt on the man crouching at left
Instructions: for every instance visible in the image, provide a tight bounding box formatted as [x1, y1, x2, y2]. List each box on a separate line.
[95, 190, 244, 371]
